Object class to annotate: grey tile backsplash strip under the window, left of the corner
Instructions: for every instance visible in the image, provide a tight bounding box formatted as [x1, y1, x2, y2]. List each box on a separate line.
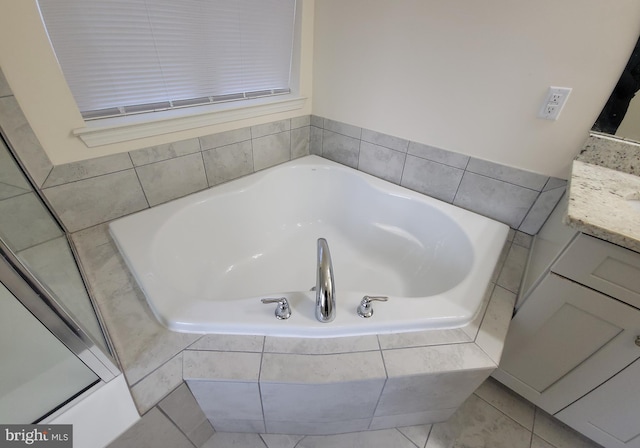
[42, 116, 309, 232]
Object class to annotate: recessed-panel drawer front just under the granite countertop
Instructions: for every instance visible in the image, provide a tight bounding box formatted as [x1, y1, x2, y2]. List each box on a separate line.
[551, 234, 640, 308]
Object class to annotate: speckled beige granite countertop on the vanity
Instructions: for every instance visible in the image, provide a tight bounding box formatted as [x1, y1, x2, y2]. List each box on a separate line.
[565, 135, 640, 252]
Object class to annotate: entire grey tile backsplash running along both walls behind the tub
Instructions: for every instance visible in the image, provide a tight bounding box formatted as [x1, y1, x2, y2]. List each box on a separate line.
[0, 66, 566, 235]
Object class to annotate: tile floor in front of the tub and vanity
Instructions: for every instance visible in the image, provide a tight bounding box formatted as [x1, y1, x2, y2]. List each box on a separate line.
[203, 378, 600, 448]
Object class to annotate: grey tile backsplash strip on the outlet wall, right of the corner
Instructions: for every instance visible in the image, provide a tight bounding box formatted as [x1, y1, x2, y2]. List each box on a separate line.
[309, 116, 566, 235]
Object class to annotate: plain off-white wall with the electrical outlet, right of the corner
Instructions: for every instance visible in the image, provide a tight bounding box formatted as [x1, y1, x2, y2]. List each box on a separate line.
[312, 0, 640, 177]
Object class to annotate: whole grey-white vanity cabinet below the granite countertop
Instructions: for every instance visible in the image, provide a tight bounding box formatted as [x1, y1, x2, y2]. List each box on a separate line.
[493, 196, 640, 448]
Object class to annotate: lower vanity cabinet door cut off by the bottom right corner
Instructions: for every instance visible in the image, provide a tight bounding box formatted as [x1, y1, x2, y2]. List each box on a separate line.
[556, 360, 640, 448]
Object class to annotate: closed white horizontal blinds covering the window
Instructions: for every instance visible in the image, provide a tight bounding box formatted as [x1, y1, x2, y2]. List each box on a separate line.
[38, 0, 295, 119]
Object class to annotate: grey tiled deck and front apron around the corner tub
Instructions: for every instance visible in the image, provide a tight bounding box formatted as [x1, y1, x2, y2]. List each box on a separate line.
[72, 225, 528, 433]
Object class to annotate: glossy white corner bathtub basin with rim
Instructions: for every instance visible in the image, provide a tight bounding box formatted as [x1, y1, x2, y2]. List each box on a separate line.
[109, 156, 508, 337]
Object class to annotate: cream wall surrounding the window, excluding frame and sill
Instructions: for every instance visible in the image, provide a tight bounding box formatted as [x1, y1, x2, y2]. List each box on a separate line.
[0, 0, 314, 165]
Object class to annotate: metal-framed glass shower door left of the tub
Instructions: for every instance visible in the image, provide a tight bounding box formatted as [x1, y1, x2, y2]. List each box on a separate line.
[0, 121, 119, 424]
